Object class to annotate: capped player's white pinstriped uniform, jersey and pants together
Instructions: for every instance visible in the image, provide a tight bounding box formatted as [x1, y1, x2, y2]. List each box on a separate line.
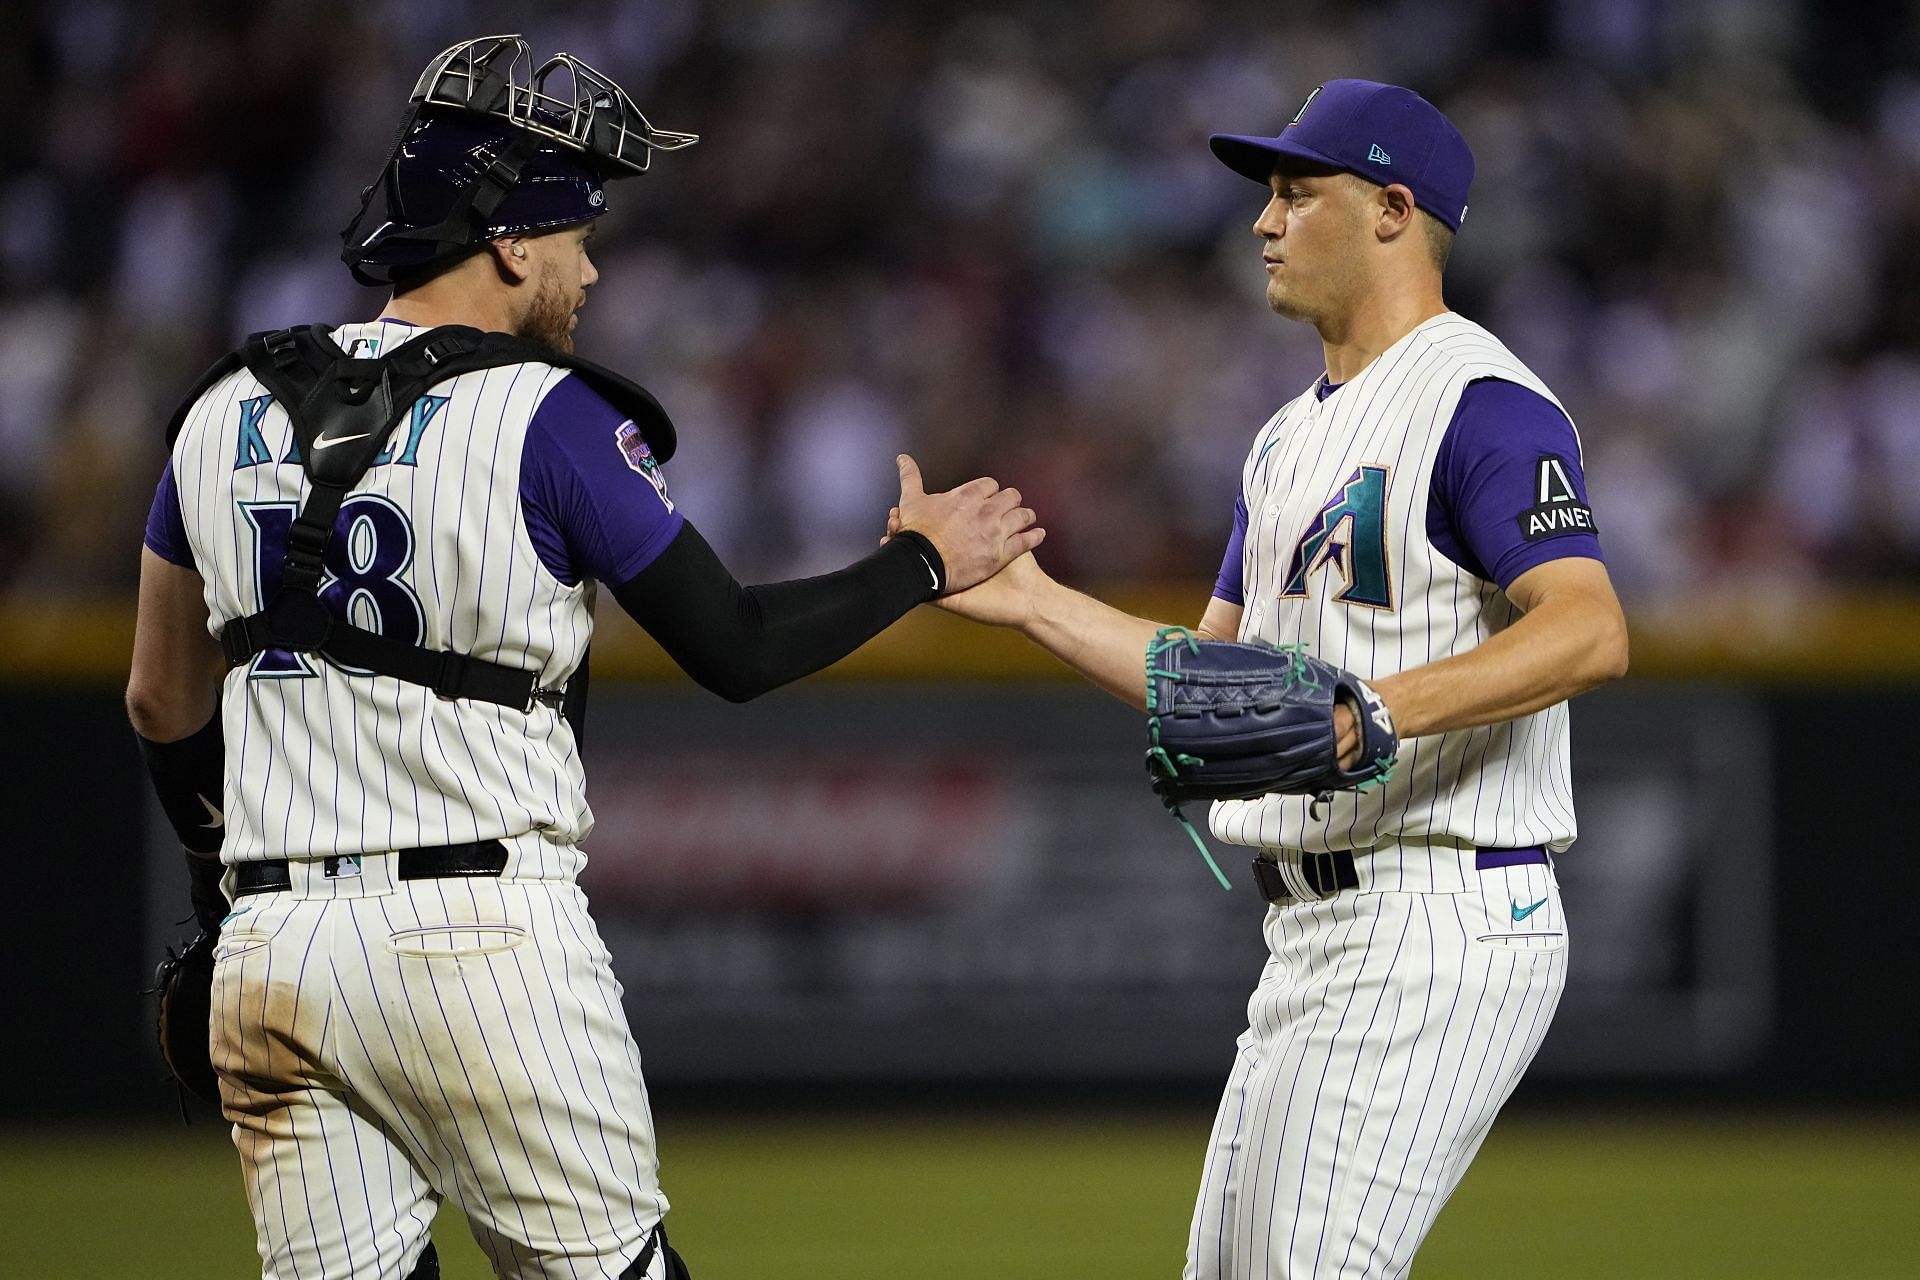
[1185, 315, 1574, 1280]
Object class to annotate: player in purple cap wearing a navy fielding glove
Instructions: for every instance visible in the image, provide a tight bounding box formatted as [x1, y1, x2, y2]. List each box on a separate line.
[921, 81, 1626, 1280]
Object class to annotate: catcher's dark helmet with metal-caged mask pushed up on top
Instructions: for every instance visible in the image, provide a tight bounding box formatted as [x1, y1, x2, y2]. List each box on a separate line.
[340, 35, 699, 284]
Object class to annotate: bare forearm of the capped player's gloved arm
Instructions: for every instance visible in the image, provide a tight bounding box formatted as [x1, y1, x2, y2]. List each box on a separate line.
[1371, 597, 1626, 739]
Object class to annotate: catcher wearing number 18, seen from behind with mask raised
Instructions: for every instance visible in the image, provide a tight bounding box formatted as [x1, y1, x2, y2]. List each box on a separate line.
[139, 35, 1044, 1280]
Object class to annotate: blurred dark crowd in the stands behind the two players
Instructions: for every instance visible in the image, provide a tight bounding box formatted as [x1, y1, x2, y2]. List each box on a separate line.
[0, 0, 1920, 606]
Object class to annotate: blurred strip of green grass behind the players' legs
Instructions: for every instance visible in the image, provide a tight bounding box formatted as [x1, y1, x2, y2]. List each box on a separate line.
[0, 1113, 1920, 1280]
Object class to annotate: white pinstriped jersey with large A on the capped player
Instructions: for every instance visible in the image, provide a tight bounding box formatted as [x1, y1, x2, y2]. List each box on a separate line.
[1212, 313, 1574, 852]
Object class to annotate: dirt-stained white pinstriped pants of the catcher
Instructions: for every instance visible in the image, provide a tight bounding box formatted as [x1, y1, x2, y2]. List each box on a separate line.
[213, 856, 666, 1280]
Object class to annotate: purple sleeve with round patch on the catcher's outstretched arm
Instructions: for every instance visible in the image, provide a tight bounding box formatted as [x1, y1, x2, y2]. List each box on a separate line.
[520, 374, 685, 587]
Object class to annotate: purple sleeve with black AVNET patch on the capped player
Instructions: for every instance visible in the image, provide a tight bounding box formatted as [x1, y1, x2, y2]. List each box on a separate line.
[1427, 378, 1605, 589]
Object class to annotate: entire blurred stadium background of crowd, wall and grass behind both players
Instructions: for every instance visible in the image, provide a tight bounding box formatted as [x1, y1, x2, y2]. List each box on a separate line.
[0, 0, 1920, 1278]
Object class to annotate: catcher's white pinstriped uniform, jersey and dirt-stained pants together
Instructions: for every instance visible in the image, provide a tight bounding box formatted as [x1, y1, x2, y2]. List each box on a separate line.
[185, 322, 666, 1280]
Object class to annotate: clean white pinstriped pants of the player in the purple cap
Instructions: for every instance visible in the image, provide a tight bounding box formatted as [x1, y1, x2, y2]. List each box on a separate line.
[1185, 865, 1567, 1280]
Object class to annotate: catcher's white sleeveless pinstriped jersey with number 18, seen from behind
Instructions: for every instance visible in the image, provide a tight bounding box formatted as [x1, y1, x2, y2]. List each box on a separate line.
[173, 322, 593, 873]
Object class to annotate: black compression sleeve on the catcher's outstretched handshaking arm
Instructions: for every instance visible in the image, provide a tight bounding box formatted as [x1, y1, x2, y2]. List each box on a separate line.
[612, 524, 945, 702]
